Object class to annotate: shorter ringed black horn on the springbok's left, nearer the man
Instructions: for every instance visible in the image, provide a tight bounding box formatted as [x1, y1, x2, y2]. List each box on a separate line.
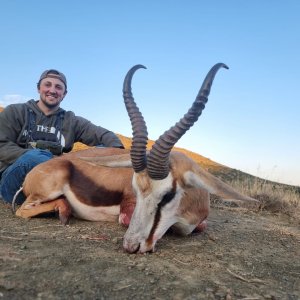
[123, 65, 148, 172]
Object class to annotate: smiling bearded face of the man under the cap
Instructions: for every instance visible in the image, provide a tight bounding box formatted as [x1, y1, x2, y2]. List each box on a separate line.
[38, 77, 66, 108]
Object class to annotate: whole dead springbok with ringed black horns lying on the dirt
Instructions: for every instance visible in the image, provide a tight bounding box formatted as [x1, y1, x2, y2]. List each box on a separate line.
[13, 63, 256, 253]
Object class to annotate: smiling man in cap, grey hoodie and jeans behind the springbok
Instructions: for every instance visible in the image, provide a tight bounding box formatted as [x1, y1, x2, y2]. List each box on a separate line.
[0, 69, 124, 203]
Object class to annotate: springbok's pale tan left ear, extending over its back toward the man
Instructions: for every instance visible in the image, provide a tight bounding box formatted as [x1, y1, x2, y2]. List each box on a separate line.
[79, 154, 132, 168]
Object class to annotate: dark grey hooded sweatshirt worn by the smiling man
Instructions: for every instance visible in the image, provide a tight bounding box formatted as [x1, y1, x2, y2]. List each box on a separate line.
[0, 100, 123, 173]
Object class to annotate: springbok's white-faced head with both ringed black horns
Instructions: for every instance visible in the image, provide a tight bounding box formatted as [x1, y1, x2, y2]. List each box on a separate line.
[123, 63, 228, 253]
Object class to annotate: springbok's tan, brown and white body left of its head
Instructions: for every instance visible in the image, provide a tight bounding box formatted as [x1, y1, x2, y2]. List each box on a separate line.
[16, 148, 135, 225]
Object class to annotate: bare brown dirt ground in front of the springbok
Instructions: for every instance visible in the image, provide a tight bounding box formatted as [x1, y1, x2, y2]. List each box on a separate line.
[0, 200, 300, 300]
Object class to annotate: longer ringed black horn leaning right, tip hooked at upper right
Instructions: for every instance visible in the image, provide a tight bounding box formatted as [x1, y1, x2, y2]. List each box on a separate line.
[147, 63, 228, 180]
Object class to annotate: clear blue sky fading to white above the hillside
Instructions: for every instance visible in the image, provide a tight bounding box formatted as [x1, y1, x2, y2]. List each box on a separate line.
[0, 0, 300, 185]
